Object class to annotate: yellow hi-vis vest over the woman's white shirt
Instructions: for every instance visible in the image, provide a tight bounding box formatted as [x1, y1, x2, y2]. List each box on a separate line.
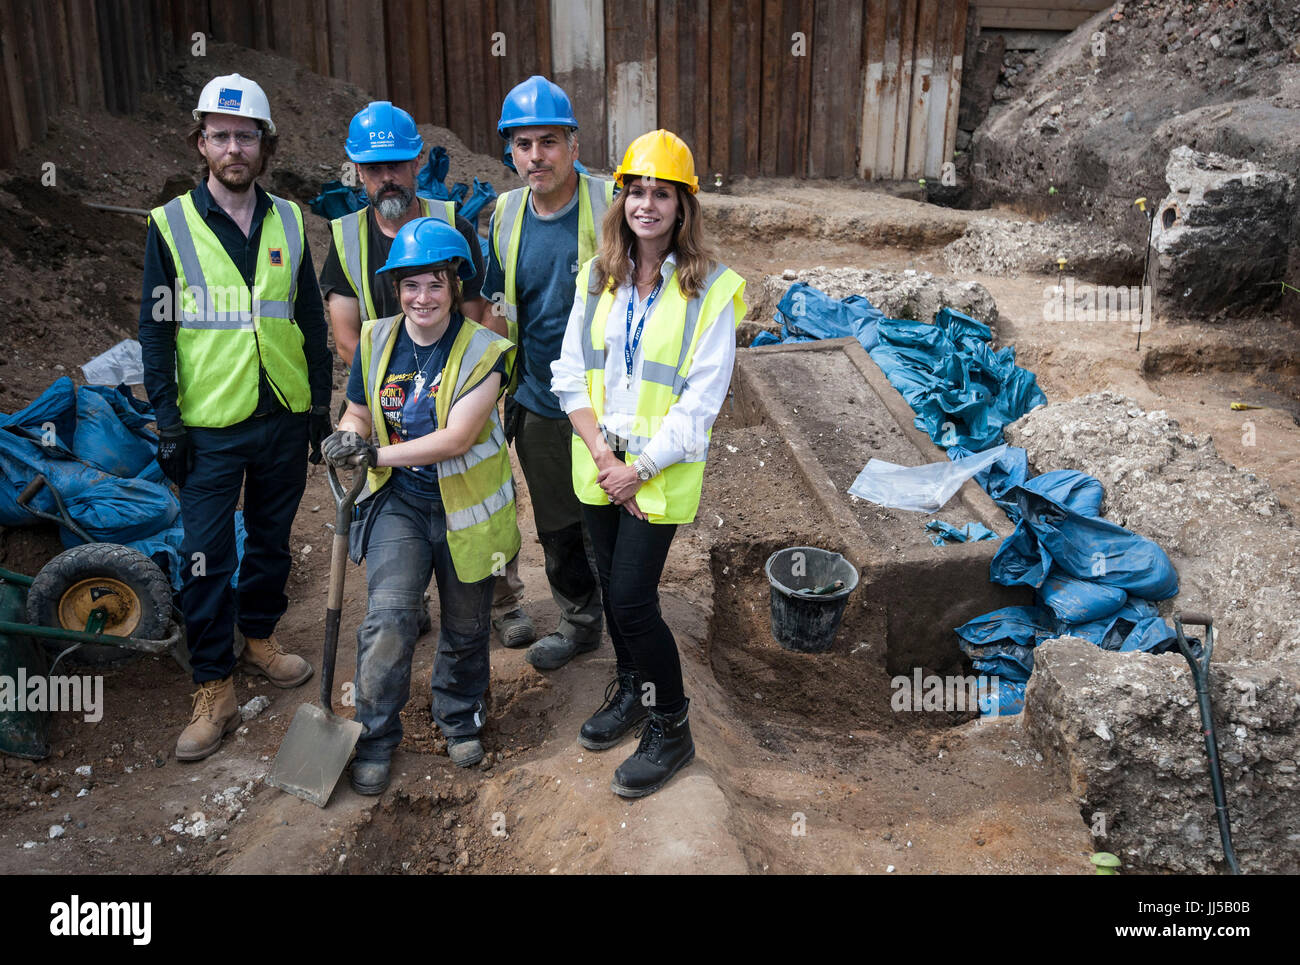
[572, 259, 745, 523]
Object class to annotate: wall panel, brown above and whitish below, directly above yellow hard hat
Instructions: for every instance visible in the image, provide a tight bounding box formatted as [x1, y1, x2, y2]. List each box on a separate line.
[605, 0, 658, 167]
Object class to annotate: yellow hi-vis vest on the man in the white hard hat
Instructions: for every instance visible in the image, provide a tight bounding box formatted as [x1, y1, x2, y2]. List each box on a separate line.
[150, 194, 312, 428]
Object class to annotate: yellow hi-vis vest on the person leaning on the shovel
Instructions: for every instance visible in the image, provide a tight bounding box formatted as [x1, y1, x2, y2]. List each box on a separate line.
[361, 315, 520, 583]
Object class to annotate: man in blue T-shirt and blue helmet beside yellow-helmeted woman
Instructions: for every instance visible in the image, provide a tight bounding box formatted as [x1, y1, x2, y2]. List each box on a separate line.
[484, 75, 614, 670]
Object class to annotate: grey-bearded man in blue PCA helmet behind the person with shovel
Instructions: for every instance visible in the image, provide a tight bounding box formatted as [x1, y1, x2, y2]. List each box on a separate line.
[321, 100, 536, 645]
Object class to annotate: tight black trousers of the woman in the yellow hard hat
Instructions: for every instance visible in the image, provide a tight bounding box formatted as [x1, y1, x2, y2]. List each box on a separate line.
[582, 505, 686, 714]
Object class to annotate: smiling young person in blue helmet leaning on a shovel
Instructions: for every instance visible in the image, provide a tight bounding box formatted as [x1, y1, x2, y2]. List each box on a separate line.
[322, 218, 520, 795]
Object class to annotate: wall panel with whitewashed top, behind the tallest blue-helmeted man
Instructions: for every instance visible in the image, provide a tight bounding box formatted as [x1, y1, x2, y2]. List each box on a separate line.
[550, 0, 605, 170]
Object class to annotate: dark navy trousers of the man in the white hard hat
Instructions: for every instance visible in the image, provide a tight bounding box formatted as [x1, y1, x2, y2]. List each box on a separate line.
[181, 411, 308, 684]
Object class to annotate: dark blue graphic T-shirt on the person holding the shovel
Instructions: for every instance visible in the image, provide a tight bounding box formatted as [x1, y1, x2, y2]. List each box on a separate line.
[347, 315, 506, 499]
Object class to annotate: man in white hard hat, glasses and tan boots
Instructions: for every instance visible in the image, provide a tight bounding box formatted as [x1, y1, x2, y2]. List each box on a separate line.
[139, 74, 332, 761]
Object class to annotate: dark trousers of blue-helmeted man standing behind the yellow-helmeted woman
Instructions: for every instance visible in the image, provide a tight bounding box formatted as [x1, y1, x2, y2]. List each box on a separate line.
[515, 408, 601, 644]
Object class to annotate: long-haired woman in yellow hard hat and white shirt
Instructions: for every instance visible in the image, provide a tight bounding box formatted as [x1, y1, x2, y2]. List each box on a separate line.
[551, 130, 745, 797]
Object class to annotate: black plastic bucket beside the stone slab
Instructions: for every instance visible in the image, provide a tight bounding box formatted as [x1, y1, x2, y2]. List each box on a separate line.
[763, 546, 858, 653]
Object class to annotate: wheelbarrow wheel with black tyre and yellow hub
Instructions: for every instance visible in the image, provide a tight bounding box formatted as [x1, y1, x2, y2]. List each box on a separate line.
[27, 542, 172, 666]
